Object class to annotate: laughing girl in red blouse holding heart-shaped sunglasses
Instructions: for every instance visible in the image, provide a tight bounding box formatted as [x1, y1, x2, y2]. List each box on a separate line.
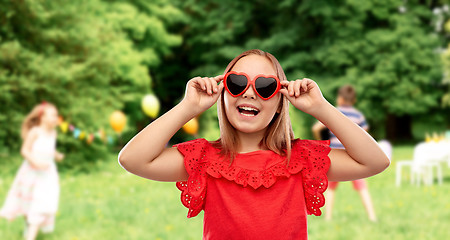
[119, 50, 389, 239]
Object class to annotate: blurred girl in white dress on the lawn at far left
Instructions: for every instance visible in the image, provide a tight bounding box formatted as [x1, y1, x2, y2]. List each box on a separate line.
[0, 102, 64, 240]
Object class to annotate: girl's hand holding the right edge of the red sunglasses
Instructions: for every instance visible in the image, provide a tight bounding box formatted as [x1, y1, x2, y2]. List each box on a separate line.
[280, 78, 327, 116]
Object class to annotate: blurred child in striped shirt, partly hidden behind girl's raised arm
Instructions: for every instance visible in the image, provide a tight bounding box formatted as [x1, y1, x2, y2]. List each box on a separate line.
[312, 85, 378, 222]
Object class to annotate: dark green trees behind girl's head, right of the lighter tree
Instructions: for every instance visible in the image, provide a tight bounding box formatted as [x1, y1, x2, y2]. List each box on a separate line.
[155, 0, 444, 140]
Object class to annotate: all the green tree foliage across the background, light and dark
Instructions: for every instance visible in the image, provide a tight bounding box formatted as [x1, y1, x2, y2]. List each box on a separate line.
[0, 0, 450, 167]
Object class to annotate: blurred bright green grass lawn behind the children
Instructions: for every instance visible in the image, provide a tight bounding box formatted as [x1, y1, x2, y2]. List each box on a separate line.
[0, 146, 450, 240]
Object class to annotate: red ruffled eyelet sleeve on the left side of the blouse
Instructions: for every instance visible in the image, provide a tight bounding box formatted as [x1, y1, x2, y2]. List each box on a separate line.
[174, 139, 209, 218]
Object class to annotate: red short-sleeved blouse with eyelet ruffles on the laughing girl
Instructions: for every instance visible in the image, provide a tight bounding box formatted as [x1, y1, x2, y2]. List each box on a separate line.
[175, 139, 330, 240]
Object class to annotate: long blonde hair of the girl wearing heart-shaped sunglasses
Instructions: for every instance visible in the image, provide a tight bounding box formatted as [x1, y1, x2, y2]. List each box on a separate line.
[214, 49, 294, 162]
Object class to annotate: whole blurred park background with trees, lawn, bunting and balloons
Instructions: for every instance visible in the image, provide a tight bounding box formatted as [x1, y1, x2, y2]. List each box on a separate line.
[0, 0, 450, 239]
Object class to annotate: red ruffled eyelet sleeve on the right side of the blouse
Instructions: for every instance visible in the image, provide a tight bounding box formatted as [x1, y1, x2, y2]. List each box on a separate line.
[292, 140, 331, 216]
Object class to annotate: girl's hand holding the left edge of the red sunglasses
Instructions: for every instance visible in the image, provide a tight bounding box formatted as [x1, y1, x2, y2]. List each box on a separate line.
[183, 75, 224, 115]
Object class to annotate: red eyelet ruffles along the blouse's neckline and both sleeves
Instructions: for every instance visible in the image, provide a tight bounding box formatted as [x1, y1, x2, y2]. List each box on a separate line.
[175, 139, 331, 218]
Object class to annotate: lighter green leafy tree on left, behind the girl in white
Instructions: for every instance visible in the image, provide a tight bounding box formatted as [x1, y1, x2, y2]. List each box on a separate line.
[0, 0, 181, 169]
